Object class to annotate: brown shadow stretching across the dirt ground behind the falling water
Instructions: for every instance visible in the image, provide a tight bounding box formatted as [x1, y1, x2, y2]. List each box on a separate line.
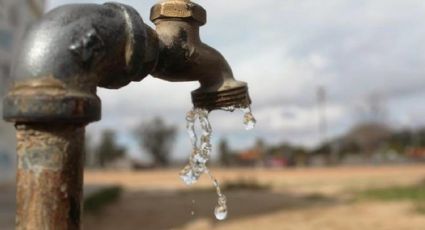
[84, 190, 338, 230]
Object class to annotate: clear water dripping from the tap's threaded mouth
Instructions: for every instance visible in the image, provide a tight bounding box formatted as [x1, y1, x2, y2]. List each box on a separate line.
[180, 107, 256, 220]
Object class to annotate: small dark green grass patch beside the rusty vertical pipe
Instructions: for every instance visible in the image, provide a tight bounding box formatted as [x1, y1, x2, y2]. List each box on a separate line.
[84, 186, 122, 213]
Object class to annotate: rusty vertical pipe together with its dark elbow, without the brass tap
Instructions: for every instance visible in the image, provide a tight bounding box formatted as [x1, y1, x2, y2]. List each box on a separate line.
[3, 3, 158, 230]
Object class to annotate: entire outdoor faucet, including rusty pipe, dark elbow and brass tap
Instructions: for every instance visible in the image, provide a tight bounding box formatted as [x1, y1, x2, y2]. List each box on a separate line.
[3, 0, 251, 229]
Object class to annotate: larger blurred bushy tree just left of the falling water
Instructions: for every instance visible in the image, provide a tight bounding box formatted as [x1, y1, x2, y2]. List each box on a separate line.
[135, 117, 177, 166]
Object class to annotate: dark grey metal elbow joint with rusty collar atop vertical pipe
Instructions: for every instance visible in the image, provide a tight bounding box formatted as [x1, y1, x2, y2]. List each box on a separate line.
[3, 3, 158, 123]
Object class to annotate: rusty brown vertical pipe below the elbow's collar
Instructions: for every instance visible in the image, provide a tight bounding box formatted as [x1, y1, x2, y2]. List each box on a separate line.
[16, 123, 85, 230]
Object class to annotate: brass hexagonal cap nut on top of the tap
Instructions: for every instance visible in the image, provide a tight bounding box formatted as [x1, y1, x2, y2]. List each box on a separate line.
[150, 0, 207, 26]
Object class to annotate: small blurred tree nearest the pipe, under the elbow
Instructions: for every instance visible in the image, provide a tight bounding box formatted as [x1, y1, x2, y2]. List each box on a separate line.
[95, 130, 126, 168]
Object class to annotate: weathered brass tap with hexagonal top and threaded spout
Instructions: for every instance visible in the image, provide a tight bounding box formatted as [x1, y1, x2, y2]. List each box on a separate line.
[150, 0, 251, 110]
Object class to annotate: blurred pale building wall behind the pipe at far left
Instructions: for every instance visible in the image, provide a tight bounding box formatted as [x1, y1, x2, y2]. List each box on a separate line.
[0, 0, 45, 182]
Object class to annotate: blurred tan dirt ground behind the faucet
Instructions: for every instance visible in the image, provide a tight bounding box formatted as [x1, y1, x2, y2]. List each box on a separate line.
[84, 165, 425, 230]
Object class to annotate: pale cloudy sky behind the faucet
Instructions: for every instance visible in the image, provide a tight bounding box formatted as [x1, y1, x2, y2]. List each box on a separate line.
[44, 0, 425, 162]
